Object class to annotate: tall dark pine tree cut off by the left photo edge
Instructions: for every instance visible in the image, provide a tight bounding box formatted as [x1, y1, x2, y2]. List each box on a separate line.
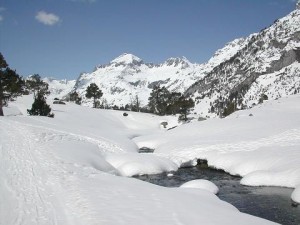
[0, 53, 24, 116]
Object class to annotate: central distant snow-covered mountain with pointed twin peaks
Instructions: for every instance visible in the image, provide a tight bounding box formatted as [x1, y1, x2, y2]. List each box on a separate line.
[75, 53, 203, 106]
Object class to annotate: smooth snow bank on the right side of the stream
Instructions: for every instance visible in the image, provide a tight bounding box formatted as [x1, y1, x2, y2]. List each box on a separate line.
[134, 95, 300, 202]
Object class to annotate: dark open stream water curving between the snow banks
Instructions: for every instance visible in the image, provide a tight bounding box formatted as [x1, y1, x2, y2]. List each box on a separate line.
[136, 167, 300, 225]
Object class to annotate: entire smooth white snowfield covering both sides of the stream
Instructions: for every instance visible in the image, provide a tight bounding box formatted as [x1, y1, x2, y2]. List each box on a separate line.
[0, 95, 300, 225]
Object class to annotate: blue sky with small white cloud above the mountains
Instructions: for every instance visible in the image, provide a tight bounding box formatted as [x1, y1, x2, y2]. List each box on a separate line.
[0, 0, 295, 79]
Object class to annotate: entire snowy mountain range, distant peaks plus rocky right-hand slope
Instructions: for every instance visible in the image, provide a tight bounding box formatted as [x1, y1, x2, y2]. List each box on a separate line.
[45, 7, 300, 117]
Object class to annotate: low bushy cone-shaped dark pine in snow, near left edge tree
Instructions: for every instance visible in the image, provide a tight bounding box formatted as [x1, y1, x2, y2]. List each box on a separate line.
[27, 92, 54, 117]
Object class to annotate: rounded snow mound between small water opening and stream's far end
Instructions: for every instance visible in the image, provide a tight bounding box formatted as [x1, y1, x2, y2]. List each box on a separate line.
[105, 153, 178, 177]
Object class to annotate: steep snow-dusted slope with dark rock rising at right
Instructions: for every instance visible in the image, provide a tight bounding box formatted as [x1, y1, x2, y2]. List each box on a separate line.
[186, 9, 300, 116]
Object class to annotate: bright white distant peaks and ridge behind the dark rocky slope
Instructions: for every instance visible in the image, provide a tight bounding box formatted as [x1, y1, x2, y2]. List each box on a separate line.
[45, 39, 244, 106]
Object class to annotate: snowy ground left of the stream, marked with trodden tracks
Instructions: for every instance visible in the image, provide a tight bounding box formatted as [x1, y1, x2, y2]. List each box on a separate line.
[0, 96, 274, 225]
